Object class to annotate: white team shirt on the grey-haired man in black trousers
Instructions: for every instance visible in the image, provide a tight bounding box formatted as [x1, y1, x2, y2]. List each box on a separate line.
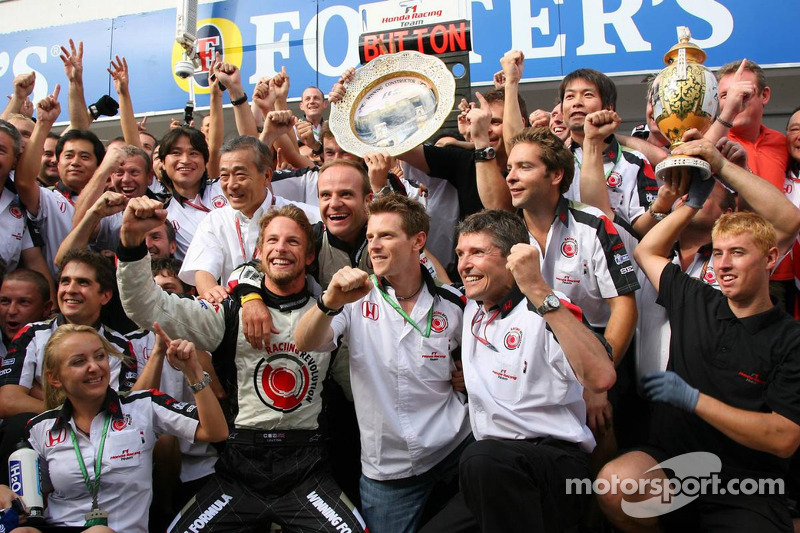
[461, 285, 595, 452]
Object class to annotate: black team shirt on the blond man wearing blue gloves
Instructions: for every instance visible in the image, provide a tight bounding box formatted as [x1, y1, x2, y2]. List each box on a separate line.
[651, 264, 800, 479]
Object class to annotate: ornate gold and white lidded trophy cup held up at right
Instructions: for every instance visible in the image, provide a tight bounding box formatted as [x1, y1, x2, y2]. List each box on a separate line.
[652, 26, 719, 180]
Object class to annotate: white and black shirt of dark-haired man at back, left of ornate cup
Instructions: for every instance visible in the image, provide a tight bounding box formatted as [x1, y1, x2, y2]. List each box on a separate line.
[564, 135, 658, 224]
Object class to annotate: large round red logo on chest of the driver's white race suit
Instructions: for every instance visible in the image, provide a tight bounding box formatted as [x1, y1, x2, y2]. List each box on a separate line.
[253, 353, 318, 413]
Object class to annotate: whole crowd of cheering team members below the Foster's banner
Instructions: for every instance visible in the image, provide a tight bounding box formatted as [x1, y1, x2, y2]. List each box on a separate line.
[0, 34, 800, 533]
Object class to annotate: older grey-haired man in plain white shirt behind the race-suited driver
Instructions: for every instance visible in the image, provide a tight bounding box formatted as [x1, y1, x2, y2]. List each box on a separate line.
[180, 132, 320, 303]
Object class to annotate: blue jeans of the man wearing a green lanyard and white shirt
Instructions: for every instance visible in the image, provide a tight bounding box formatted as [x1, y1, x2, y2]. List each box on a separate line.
[359, 435, 475, 533]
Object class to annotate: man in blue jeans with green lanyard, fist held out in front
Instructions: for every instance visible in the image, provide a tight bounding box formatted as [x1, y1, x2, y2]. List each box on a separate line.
[295, 194, 473, 533]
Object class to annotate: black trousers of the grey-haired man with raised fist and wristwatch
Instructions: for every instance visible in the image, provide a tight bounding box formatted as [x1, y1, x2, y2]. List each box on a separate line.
[422, 438, 590, 533]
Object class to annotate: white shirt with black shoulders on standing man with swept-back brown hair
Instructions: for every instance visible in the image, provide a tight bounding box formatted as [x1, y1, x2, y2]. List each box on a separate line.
[530, 196, 639, 327]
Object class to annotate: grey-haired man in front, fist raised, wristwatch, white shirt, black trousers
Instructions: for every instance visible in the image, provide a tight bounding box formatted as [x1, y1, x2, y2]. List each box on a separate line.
[423, 210, 615, 533]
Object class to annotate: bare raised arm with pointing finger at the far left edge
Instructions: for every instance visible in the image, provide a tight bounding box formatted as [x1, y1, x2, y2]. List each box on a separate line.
[14, 85, 61, 216]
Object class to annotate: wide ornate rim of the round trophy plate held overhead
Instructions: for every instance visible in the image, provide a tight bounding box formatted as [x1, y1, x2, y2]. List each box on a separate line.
[328, 51, 456, 157]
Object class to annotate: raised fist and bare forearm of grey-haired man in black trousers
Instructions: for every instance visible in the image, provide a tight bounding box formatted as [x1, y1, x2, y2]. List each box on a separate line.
[507, 244, 616, 393]
